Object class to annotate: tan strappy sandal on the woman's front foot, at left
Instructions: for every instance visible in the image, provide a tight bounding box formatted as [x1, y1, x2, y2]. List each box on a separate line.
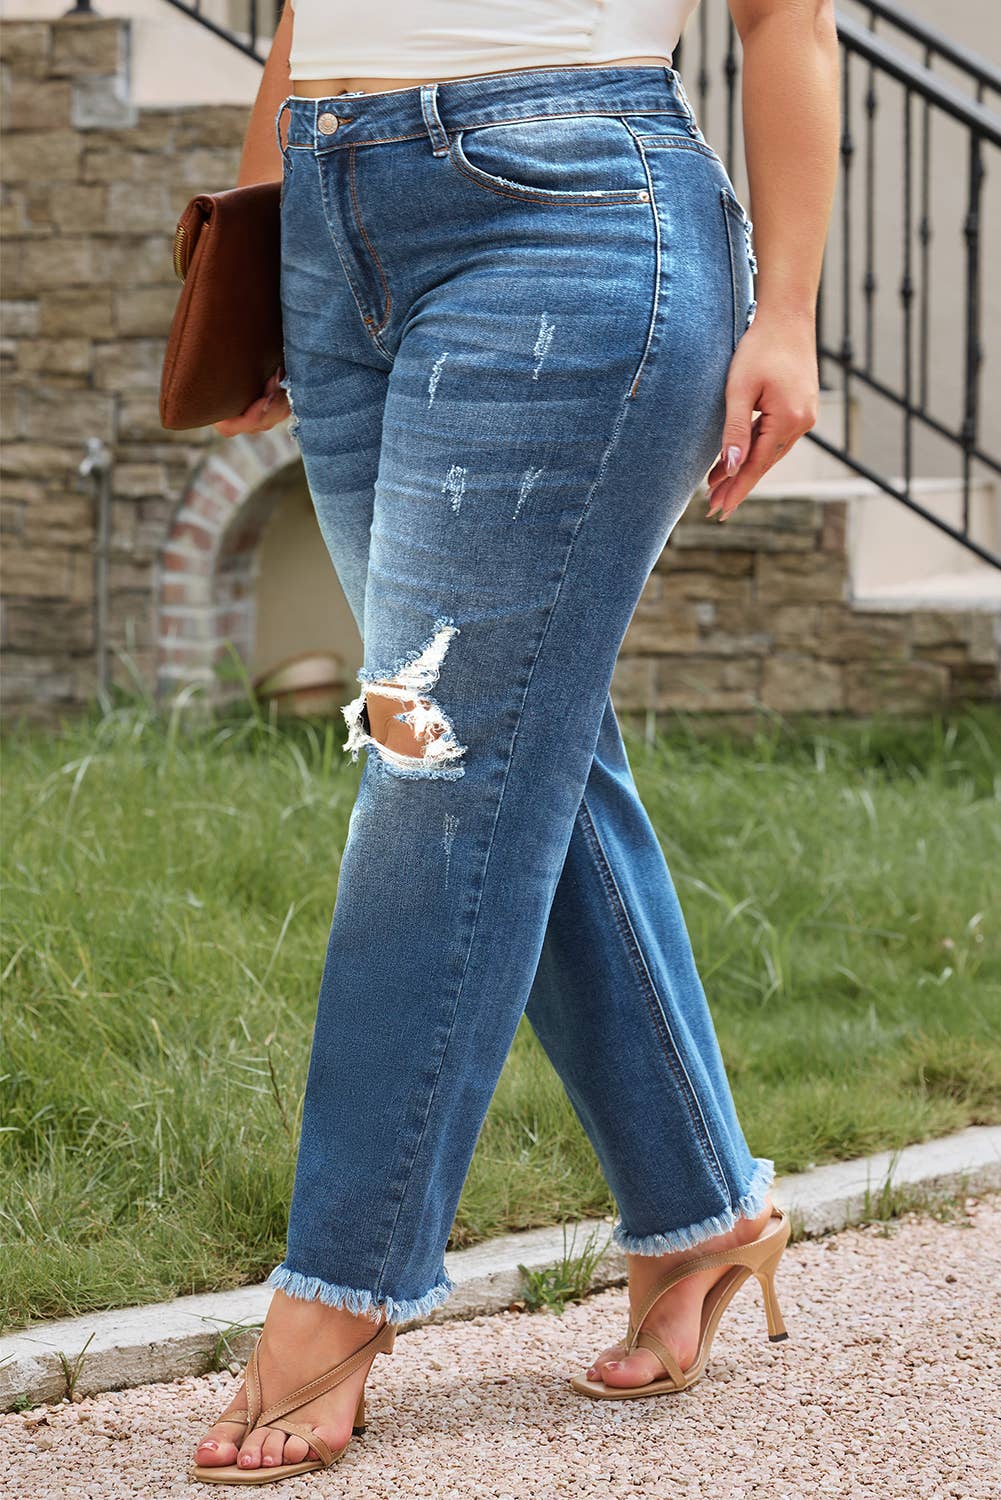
[188, 1323, 396, 1485]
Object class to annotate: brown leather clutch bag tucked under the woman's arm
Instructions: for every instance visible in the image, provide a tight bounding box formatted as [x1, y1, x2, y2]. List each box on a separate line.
[161, 183, 284, 432]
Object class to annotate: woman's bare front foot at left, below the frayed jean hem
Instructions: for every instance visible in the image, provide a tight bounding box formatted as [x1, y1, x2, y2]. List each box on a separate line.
[195, 1290, 380, 1469]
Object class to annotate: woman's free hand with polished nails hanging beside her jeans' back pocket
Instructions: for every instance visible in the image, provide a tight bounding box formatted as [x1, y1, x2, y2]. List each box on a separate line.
[705, 308, 819, 521]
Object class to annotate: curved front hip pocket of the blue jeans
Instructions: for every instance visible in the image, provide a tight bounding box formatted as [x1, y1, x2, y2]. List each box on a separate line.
[449, 114, 650, 206]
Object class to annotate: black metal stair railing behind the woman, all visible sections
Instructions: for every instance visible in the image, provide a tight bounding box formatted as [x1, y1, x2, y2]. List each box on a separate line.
[160, 0, 1001, 569]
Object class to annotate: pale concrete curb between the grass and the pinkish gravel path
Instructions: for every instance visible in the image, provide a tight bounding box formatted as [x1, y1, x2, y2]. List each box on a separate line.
[0, 1125, 1001, 1412]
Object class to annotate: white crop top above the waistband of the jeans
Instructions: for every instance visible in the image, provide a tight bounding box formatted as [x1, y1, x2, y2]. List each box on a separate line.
[288, 0, 698, 80]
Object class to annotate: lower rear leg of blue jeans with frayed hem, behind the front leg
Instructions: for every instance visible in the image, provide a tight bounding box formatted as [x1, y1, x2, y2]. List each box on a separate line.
[527, 701, 773, 1256]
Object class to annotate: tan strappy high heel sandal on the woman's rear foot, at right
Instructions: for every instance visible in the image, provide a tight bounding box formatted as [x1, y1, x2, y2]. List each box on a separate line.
[569, 1208, 789, 1401]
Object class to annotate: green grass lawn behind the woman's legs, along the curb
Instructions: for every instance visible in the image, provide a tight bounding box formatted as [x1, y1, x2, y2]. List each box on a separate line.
[0, 690, 1001, 1326]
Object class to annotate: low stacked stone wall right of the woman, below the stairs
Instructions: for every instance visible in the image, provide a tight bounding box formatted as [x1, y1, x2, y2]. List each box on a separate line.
[612, 495, 1001, 717]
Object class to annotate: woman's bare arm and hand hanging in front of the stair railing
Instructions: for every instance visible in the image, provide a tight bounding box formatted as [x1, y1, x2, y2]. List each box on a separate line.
[708, 0, 840, 521]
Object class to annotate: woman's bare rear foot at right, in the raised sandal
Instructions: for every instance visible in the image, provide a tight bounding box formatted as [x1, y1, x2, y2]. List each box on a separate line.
[587, 1199, 771, 1386]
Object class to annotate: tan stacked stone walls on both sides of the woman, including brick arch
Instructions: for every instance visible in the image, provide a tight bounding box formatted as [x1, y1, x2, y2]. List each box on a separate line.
[0, 17, 1001, 717]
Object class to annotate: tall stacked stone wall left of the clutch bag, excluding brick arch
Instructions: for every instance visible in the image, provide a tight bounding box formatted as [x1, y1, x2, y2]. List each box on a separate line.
[0, 18, 246, 714]
